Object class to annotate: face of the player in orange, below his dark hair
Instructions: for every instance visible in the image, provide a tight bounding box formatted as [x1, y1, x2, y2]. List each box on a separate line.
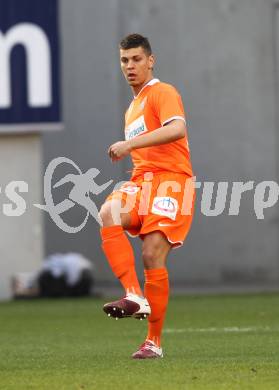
[120, 46, 154, 90]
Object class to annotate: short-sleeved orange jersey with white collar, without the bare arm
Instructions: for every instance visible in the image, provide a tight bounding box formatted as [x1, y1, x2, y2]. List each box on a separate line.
[125, 79, 193, 176]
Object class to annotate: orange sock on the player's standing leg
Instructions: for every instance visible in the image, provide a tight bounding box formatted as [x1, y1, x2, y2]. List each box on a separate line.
[144, 268, 169, 346]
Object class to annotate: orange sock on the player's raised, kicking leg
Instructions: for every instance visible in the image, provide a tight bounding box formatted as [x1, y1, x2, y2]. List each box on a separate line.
[101, 225, 143, 295]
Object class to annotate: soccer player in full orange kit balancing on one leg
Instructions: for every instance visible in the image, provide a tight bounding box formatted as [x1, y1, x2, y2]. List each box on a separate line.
[100, 34, 194, 359]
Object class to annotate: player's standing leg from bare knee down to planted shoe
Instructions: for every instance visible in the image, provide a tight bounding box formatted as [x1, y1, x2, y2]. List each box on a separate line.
[132, 231, 171, 359]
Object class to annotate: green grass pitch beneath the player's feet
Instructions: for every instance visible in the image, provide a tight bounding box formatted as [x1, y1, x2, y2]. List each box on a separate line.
[0, 294, 279, 390]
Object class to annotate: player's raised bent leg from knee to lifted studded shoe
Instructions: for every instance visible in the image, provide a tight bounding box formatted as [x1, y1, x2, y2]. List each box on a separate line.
[100, 199, 151, 319]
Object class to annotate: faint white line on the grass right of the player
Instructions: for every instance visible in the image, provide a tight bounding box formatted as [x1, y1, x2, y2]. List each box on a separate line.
[163, 326, 274, 333]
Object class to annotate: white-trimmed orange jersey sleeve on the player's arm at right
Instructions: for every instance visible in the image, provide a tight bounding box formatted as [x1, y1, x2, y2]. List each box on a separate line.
[153, 85, 186, 126]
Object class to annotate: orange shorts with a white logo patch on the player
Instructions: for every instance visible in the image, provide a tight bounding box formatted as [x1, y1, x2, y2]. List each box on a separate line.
[106, 172, 195, 247]
